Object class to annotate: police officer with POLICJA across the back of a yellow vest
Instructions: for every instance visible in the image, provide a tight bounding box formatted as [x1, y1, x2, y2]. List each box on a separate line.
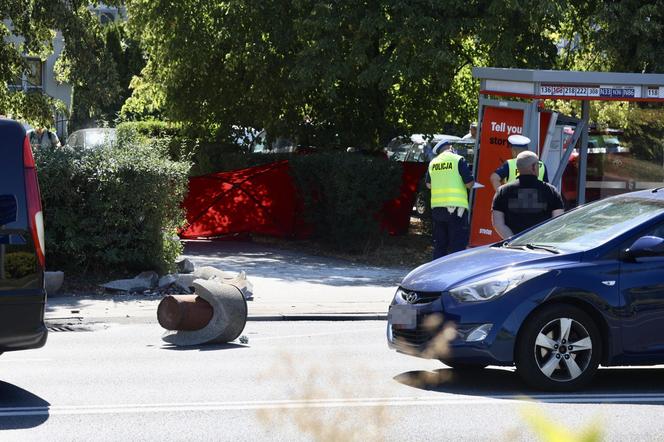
[426, 140, 474, 259]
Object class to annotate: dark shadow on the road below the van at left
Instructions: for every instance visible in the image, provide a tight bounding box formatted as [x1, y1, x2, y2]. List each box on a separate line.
[0, 381, 51, 430]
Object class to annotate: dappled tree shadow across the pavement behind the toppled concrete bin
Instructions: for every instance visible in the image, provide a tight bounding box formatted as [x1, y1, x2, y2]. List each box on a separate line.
[179, 240, 408, 287]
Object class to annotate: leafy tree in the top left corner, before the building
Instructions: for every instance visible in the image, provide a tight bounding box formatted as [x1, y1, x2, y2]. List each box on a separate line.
[0, 0, 118, 125]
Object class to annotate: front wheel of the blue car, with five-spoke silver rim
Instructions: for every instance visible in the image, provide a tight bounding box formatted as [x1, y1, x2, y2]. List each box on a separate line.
[515, 304, 602, 391]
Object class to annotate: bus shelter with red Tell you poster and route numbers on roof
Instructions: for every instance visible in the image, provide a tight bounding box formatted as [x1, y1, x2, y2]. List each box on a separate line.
[470, 68, 664, 246]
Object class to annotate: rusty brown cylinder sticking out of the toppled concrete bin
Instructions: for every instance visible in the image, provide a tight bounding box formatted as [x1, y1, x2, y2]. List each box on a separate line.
[157, 295, 214, 330]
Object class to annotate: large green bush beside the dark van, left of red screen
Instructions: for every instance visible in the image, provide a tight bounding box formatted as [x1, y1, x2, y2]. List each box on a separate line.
[35, 134, 190, 273]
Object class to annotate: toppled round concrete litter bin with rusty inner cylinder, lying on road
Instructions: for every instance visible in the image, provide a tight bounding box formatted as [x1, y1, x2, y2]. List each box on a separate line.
[157, 279, 247, 346]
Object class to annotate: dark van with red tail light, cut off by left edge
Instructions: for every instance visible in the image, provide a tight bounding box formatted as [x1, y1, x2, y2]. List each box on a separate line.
[0, 118, 47, 353]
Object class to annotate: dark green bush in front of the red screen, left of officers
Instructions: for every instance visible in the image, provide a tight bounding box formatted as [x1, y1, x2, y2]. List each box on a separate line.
[290, 153, 402, 252]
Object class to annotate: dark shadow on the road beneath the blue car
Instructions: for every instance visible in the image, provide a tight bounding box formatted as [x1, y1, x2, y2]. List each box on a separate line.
[394, 367, 664, 405]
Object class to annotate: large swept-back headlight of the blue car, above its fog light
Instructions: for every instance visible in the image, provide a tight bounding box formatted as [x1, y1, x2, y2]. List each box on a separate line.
[449, 269, 548, 302]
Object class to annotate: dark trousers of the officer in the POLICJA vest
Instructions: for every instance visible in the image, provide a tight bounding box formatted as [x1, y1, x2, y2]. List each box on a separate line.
[431, 207, 470, 259]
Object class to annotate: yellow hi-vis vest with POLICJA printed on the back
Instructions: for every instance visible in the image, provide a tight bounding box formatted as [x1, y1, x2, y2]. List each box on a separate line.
[429, 152, 468, 209]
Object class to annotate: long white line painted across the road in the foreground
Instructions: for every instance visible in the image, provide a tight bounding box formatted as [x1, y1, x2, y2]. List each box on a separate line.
[0, 393, 664, 418]
